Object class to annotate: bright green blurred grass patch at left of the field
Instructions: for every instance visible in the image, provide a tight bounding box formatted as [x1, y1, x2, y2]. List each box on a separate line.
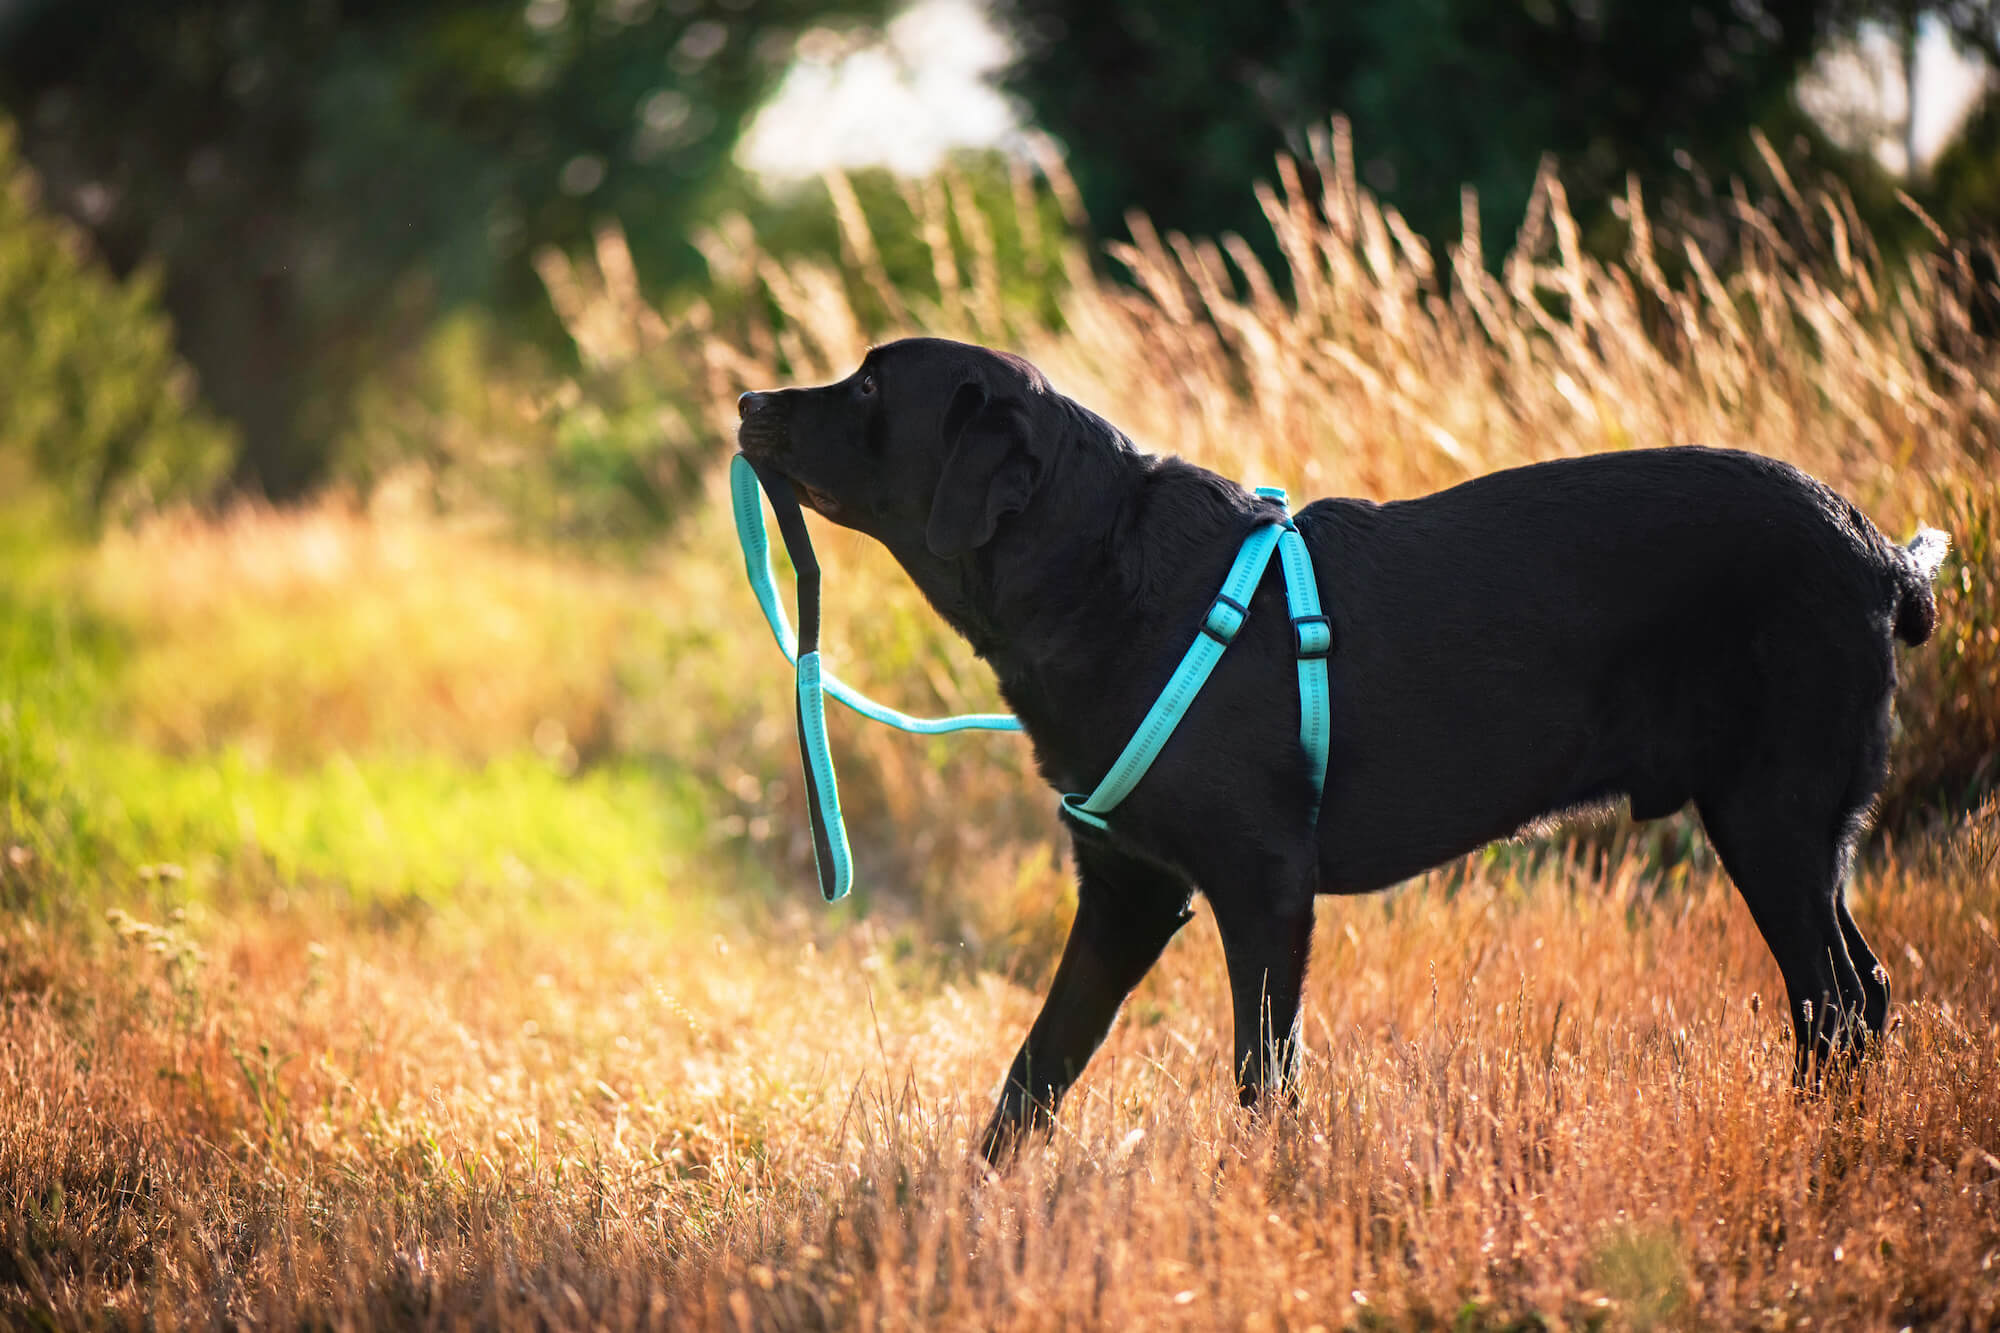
[0, 492, 712, 911]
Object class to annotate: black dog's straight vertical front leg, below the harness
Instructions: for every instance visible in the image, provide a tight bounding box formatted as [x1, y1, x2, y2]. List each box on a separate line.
[1208, 876, 1312, 1107]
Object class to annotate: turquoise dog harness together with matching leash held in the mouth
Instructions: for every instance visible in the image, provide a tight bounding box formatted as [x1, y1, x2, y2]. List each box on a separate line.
[730, 454, 1334, 903]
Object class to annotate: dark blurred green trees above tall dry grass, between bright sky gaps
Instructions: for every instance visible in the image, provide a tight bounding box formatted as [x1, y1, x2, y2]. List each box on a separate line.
[996, 0, 1834, 260]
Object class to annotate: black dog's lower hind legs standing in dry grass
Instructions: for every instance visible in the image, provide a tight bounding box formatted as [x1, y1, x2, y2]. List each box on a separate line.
[1696, 769, 1888, 1083]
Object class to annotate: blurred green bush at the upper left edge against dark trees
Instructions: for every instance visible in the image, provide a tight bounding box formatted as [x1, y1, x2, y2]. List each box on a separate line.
[0, 118, 232, 524]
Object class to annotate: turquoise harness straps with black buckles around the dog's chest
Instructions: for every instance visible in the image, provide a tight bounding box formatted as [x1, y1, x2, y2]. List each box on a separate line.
[1060, 486, 1334, 829]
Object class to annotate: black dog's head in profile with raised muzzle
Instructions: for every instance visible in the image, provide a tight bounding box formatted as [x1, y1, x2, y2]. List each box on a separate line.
[736, 338, 1060, 560]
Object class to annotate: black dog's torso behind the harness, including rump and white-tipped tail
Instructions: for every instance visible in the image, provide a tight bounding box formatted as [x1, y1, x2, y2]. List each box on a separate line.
[1300, 448, 1942, 891]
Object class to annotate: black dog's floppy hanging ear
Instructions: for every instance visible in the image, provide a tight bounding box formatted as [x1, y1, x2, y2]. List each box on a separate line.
[924, 384, 1042, 560]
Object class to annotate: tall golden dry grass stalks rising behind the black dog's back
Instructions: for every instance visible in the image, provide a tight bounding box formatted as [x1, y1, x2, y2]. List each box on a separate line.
[628, 122, 2000, 508]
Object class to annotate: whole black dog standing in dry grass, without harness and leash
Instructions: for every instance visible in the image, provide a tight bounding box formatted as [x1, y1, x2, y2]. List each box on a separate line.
[740, 338, 1944, 1157]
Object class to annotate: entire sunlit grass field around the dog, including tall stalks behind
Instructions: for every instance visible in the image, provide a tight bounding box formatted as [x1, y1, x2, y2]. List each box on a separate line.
[0, 136, 2000, 1329]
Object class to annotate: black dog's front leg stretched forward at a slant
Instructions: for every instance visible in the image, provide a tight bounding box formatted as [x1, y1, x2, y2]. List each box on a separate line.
[980, 839, 1192, 1165]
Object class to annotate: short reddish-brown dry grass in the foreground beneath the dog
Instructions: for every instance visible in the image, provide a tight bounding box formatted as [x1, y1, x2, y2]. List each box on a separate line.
[11, 817, 2000, 1329]
